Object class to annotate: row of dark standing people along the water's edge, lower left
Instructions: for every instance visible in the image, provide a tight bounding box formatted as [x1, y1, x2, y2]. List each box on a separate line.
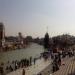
[0, 57, 40, 75]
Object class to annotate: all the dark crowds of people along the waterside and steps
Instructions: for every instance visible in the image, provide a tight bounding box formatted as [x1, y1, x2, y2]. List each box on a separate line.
[0, 47, 74, 75]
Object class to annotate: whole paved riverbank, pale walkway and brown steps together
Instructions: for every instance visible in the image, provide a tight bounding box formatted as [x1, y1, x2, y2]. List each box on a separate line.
[7, 57, 75, 75]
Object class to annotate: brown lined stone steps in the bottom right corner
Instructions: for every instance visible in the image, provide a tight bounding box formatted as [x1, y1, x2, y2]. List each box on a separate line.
[53, 58, 75, 75]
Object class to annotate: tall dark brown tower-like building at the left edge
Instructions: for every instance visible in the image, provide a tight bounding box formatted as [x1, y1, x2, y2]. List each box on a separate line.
[0, 23, 5, 47]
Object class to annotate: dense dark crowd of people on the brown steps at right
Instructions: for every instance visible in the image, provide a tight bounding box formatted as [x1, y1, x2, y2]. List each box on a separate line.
[52, 50, 74, 72]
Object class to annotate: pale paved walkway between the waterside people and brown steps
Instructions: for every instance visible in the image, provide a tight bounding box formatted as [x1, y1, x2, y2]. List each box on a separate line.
[7, 58, 51, 75]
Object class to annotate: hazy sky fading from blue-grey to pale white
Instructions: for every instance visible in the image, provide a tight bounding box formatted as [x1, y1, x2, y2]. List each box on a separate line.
[0, 0, 75, 37]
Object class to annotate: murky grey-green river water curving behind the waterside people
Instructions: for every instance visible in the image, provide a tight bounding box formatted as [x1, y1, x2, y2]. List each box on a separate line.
[0, 43, 44, 63]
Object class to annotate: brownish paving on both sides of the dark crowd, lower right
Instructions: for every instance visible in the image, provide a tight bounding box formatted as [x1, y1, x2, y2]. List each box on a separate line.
[41, 57, 75, 75]
